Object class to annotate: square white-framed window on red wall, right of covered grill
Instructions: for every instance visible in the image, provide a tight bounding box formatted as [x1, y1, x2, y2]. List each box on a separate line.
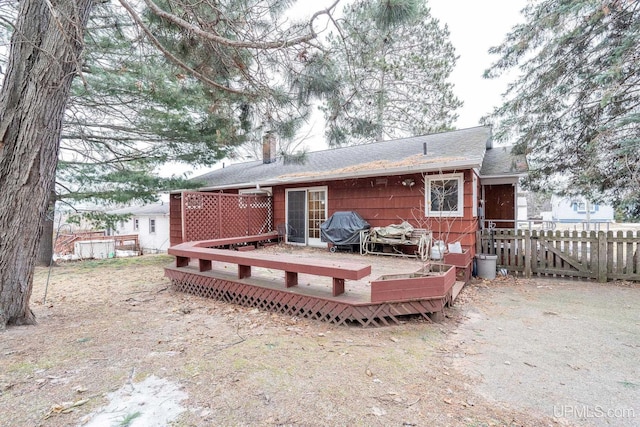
[425, 173, 464, 217]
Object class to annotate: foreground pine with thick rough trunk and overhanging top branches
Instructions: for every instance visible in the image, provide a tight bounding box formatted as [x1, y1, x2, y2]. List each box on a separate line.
[0, 0, 340, 329]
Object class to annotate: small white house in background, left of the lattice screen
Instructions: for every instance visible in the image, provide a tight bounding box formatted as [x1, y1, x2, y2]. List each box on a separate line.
[109, 203, 169, 254]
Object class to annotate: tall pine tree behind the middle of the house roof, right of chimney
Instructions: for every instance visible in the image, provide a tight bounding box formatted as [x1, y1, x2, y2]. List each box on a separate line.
[323, 0, 462, 145]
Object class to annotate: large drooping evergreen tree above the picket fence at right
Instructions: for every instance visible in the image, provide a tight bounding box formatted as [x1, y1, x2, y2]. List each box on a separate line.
[485, 0, 640, 218]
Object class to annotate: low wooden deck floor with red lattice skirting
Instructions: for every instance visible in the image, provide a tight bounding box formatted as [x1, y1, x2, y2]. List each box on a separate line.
[165, 245, 464, 326]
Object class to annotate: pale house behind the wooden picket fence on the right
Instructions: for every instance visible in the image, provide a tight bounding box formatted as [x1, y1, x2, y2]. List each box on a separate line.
[551, 195, 614, 223]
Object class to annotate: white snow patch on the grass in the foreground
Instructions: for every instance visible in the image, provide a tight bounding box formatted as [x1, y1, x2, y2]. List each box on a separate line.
[84, 375, 187, 427]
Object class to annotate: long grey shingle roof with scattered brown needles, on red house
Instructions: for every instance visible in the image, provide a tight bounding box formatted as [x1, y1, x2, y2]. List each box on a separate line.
[193, 126, 520, 189]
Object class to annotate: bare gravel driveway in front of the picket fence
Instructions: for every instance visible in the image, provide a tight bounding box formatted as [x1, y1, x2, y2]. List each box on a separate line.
[450, 279, 640, 426]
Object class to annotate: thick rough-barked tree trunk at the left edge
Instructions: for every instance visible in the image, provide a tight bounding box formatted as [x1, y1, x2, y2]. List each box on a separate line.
[0, 0, 92, 329]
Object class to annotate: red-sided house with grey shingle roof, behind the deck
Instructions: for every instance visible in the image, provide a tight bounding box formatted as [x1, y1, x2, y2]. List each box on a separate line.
[170, 126, 527, 253]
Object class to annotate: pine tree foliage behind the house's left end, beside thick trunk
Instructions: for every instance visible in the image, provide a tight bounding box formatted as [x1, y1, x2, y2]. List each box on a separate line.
[56, 3, 246, 209]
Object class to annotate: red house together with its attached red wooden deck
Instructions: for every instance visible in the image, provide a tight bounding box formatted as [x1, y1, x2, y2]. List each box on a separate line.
[165, 127, 526, 326]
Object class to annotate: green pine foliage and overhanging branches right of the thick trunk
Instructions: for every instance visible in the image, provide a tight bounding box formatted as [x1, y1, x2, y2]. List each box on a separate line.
[0, 0, 324, 214]
